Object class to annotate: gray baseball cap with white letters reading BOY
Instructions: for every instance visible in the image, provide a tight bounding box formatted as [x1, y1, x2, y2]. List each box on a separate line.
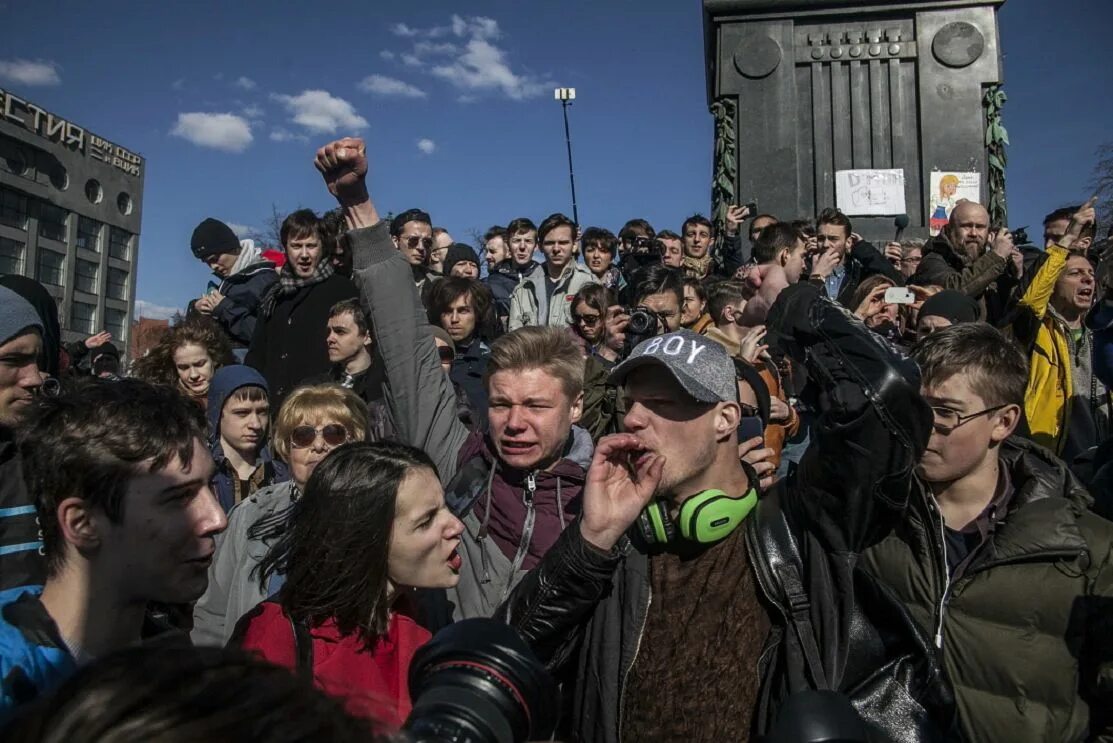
[607, 330, 738, 403]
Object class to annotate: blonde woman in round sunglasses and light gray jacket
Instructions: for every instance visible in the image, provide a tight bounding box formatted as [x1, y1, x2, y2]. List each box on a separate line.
[193, 384, 367, 645]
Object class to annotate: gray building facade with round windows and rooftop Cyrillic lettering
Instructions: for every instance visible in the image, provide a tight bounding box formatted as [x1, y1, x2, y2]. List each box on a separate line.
[0, 90, 146, 358]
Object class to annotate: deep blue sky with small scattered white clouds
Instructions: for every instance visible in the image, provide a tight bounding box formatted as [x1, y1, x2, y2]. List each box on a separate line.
[0, 0, 1113, 315]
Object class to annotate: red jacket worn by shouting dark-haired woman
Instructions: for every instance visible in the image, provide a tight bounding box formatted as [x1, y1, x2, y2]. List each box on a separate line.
[236, 601, 431, 732]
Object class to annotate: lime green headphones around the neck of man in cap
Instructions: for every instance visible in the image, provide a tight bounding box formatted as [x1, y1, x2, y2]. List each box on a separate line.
[638, 488, 758, 545]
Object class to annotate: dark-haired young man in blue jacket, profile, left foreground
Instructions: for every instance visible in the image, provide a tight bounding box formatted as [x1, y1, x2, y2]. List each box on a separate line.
[0, 379, 227, 712]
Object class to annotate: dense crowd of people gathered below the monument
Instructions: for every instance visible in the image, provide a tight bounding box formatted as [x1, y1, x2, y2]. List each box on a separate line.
[0, 138, 1113, 743]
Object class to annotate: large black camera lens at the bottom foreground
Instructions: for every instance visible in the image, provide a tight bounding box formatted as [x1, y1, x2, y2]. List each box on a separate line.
[405, 618, 560, 743]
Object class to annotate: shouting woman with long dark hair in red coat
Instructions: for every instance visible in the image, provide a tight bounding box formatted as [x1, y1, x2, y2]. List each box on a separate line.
[232, 442, 463, 730]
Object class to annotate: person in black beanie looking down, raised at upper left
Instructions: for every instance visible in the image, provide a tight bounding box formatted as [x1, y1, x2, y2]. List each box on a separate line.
[189, 217, 278, 351]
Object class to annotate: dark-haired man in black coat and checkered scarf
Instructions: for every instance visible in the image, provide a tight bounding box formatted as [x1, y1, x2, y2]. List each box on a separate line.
[244, 209, 358, 410]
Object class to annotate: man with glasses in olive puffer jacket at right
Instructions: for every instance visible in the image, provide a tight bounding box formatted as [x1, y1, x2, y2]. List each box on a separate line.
[859, 323, 1113, 741]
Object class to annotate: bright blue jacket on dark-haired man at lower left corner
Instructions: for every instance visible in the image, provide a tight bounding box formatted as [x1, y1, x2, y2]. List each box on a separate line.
[0, 587, 77, 722]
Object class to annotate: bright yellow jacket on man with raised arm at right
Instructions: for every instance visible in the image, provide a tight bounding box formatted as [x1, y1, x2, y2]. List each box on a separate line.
[1012, 245, 1073, 454]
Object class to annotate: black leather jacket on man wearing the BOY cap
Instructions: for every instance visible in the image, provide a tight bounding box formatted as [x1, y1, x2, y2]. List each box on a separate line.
[499, 284, 957, 743]
